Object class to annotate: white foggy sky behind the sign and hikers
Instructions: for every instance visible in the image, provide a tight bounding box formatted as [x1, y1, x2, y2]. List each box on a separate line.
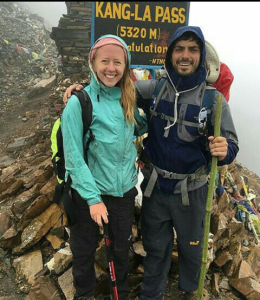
[16, 2, 260, 176]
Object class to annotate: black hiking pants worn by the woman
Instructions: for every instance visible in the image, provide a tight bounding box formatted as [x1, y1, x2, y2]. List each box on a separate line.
[70, 188, 137, 300]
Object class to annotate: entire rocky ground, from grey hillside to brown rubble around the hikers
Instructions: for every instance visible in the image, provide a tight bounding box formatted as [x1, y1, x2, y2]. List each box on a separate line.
[0, 2, 260, 300]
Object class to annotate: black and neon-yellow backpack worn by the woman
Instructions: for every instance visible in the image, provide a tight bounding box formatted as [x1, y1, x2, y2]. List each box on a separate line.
[51, 90, 95, 227]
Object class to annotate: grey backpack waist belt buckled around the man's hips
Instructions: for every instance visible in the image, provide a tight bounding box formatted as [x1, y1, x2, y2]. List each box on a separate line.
[144, 164, 208, 205]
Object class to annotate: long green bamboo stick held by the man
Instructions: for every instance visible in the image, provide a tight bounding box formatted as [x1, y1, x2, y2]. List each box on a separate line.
[197, 95, 222, 300]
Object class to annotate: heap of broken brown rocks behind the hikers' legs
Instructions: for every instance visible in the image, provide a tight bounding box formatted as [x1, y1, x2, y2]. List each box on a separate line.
[0, 130, 260, 300]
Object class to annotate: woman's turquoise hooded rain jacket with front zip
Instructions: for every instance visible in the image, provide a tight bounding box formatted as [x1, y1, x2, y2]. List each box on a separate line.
[61, 35, 146, 205]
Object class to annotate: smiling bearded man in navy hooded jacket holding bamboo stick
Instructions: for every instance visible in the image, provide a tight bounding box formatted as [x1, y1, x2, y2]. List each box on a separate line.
[65, 26, 238, 300]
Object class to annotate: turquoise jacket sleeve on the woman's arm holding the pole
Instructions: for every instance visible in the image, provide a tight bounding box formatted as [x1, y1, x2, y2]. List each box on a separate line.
[61, 95, 102, 205]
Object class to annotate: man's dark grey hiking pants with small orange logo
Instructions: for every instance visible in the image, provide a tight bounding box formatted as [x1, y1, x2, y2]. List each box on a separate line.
[141, 184, 208, 300]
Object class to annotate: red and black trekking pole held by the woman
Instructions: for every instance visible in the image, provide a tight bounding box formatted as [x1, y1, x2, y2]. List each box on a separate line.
[103, 222, 119, 300]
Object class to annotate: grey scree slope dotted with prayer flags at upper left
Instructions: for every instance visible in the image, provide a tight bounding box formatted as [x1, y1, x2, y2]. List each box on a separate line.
[0, 2, 57, 101]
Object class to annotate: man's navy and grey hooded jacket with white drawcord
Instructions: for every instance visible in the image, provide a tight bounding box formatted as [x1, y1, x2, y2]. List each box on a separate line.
[136, 26, 238, 193]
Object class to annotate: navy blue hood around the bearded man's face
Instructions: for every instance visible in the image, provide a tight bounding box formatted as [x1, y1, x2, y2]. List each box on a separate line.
[165, 26, 207, 92]
